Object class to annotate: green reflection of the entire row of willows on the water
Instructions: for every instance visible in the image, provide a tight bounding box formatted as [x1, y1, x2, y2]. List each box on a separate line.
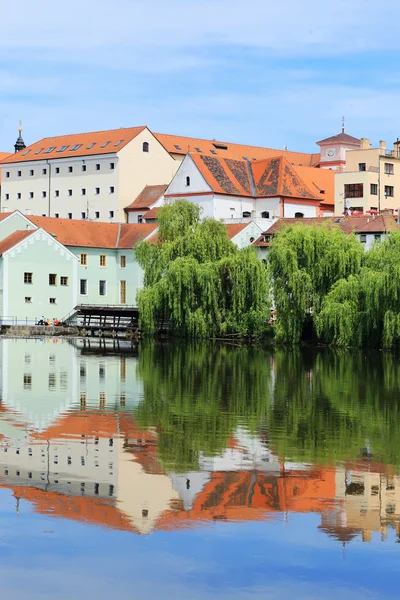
[135, 344, 400, 470]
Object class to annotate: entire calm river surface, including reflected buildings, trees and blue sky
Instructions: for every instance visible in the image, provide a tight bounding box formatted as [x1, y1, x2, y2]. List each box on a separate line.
[0, 339, 400, 600]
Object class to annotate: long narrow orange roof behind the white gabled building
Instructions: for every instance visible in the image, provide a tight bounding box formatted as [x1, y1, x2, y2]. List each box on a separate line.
[154, 133, 320, 167]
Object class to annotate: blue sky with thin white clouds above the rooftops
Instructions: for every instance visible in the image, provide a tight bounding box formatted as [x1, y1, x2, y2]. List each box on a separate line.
[0, 0, 400, 151]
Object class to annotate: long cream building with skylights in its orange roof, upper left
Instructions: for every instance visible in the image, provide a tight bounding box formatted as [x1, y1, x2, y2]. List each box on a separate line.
[0, 127, 179, 223]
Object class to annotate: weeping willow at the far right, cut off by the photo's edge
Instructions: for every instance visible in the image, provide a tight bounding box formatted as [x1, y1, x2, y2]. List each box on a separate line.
[316, 231, 400, 348]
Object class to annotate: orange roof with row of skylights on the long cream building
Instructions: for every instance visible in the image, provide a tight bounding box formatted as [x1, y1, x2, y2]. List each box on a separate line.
[1, 127, 146, 164]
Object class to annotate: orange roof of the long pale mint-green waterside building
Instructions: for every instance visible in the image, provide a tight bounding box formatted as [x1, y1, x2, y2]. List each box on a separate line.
[24, 216, 157, 248]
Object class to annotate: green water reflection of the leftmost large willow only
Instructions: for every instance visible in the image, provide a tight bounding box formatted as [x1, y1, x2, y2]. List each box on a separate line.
[135, 344, 270, 470]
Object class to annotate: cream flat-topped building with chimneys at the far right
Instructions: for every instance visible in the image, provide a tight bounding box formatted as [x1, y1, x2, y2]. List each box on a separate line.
[335, 138, 400, 215]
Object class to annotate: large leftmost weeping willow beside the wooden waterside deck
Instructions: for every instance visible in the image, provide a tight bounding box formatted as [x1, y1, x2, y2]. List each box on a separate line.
[136, 200, 269, 338]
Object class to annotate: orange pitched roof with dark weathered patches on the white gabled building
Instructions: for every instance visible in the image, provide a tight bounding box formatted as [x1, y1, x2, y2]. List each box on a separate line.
[190, 153, 321, 201]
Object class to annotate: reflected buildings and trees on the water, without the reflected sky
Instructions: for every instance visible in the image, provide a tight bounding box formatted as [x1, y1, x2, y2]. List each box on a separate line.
[0, 339, 400, 543]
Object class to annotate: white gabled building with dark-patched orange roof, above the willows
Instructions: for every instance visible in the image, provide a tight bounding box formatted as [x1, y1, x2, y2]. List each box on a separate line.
[164, 152, 334, 227]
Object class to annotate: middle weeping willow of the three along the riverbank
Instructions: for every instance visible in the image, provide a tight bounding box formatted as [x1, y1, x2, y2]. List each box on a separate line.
[268, 224, 363, 344]
